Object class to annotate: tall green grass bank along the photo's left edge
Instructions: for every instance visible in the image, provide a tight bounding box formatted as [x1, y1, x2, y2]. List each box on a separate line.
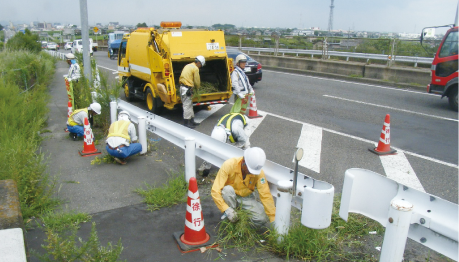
[0, 51, 59, 221]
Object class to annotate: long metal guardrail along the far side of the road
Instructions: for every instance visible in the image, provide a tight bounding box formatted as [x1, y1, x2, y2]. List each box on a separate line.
[234, 47, 433, 67]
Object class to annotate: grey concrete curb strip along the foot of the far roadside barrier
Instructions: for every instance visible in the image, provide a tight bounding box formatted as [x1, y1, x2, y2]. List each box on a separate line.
[263, 66, 426, 92]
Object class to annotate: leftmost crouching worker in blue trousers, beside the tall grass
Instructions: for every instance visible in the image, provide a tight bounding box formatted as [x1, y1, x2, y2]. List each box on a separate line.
[67, 103, 102, 141]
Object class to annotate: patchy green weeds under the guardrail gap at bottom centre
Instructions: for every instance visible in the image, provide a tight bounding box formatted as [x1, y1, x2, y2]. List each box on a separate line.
[218, 195, 384, 261]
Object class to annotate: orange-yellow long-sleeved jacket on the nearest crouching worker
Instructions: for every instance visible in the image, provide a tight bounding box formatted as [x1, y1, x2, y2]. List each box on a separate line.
[211, 157, 276, 222]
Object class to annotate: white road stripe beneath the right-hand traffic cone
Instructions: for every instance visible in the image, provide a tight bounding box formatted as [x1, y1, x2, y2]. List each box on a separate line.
[379, 152, 426, 192]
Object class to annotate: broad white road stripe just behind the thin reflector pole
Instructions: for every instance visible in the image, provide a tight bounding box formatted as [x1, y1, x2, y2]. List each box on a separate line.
[297, 125, 322, 173]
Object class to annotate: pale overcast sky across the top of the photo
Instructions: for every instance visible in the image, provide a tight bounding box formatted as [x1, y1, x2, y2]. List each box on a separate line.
[0, 0, 458, 33]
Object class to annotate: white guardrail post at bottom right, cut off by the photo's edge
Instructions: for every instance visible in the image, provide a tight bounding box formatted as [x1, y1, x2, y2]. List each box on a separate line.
[379, 199, 413, 262]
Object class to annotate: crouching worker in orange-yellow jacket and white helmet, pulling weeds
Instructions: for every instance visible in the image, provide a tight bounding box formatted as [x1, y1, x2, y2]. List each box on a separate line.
[211, 147, 276, 227]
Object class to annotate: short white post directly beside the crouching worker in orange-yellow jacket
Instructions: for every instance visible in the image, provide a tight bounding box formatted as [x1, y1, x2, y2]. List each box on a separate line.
[274, 180, 292, 242]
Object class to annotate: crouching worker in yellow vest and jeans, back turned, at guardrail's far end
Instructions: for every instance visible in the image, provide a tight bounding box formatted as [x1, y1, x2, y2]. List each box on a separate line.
[105, 111, 142, 165]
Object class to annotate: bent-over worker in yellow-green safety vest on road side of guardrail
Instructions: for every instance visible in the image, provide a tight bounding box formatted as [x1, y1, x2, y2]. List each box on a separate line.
[198, 113, 250, 177]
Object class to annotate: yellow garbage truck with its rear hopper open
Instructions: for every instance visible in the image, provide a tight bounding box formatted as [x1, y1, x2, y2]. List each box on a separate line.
[118, 22, 233, 113]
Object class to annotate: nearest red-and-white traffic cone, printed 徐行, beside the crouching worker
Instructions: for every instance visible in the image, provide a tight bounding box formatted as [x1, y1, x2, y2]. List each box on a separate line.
[173, 177, 216, 253]
